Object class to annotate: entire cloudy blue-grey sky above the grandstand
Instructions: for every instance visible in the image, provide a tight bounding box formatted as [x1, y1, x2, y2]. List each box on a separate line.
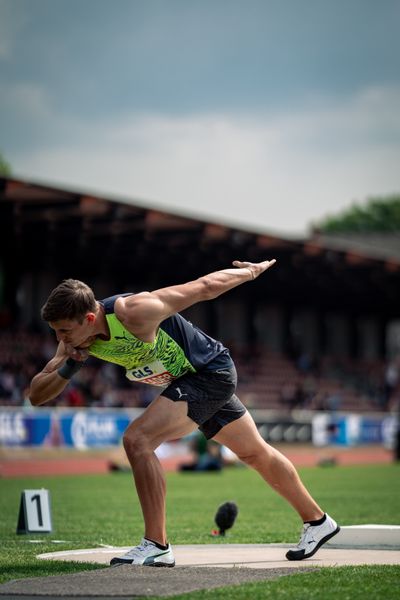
[0, 0, 400, 237]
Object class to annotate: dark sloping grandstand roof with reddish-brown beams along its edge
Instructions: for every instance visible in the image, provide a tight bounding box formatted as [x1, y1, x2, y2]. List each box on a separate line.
[0, 177, 400, 315]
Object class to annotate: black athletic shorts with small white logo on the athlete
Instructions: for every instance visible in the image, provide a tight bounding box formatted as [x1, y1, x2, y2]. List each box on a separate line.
[161, 367, 246, 440]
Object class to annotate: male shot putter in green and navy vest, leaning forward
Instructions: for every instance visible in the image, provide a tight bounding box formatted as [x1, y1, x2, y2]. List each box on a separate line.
[29, 260, 340, 567]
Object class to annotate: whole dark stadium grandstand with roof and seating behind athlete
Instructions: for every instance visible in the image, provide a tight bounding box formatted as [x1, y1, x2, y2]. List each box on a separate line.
[0, 177, 400, 413]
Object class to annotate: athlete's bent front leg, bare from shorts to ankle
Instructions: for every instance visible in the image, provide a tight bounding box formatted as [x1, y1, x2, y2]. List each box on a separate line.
[123, 396, 197, 545]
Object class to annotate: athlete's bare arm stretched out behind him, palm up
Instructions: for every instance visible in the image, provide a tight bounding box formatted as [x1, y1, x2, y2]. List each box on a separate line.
[118, 259, 276, 333]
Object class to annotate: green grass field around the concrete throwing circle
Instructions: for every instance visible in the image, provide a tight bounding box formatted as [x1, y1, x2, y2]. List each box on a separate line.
[0, 464, 400, 600]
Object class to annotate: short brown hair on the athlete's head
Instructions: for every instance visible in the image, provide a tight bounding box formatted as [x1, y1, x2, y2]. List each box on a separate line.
[41, 279, 97, 323]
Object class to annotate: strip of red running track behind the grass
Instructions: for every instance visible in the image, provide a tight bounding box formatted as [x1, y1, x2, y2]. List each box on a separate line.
[0, 446, 394, 477]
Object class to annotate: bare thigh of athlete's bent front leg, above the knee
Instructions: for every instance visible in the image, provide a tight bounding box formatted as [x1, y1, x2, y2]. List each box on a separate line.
[126, 396, 198, 445]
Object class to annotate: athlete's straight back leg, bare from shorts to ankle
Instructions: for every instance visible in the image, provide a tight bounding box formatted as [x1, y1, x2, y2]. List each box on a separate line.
[213, 413, 324, 521]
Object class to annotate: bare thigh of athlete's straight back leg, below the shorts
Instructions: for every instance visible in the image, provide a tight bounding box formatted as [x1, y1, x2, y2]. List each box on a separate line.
[213, 412, 266, 456]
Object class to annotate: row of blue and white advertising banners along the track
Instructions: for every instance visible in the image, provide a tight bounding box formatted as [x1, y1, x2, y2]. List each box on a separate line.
[0, 408, 397, 450]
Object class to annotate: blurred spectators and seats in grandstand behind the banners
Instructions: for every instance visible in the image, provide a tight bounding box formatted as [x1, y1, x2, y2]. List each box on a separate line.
[0, 331, 400, 412]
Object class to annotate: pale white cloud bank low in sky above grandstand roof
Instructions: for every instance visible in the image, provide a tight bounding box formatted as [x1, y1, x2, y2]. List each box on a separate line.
[8, 86, 400, 234]
